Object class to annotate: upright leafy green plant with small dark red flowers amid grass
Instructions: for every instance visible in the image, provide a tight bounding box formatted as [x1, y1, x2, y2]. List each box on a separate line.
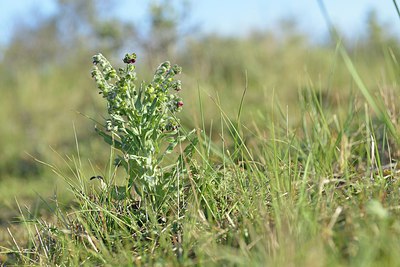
[91, 54, 183, 191]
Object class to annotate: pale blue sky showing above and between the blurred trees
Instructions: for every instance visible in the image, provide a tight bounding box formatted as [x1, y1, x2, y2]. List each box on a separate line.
[0, 0, 400, 44]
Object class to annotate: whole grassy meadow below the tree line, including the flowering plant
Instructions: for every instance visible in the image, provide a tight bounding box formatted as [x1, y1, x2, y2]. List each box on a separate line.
[0, 2, 400, 266]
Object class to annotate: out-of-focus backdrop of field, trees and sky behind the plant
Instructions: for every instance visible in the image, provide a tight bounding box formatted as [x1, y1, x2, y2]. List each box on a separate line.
[0, 0, 400, 218]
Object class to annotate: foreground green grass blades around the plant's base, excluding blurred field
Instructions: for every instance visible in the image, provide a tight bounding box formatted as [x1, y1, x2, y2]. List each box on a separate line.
[2, 68, 400, 266]
